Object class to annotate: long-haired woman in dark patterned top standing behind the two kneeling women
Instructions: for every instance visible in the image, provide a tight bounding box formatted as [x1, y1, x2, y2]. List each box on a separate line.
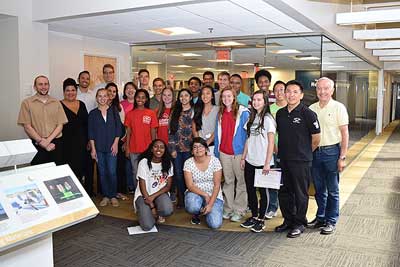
[168, 88, 194, 208]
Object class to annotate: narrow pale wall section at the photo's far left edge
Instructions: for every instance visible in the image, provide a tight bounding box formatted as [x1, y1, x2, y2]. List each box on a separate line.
[0, 17, 20, 141]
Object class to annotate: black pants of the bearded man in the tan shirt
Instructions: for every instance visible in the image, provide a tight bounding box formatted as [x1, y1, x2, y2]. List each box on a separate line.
[31, 138, 64, 165]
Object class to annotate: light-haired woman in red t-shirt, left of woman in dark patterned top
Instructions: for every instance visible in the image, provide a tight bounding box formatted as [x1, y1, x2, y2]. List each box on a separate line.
[156, 88, 175, 144]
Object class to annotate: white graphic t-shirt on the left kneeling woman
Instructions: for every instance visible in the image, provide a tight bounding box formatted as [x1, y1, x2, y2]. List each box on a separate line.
[134, 159, 174, 211]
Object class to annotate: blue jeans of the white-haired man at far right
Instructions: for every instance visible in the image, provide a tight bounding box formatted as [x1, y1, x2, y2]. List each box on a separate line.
[311, 144, 340, 225]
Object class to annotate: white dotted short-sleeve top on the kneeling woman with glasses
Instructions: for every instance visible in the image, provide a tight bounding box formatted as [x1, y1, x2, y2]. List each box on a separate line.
[183, 156, 223, 200]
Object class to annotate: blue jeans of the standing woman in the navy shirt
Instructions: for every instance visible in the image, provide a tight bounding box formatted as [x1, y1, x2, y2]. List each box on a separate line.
[96, 151, 117, 198]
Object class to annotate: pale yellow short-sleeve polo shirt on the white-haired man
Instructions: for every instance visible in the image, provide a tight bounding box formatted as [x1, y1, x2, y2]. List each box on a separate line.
[310, 99, 349, 146]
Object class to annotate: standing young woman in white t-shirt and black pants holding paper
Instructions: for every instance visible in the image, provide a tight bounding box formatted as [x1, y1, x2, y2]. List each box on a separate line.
[240, 90, 276, 233]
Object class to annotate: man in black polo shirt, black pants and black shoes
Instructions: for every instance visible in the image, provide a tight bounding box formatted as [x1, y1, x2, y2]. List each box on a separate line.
[275, 80, 320, 238]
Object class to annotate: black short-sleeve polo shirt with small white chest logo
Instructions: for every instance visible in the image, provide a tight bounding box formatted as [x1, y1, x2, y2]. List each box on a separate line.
[276, 103, 321, 162]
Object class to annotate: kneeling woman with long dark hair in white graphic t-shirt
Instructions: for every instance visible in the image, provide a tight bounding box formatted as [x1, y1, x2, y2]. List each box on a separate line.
[134, 139, 174, 231]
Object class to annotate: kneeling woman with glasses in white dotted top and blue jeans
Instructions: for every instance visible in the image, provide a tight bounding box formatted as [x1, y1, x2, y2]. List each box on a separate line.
[183, 137, 224, 229]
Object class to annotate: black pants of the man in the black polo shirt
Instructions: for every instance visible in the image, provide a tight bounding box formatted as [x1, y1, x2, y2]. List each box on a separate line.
[279, 160, 311, 228]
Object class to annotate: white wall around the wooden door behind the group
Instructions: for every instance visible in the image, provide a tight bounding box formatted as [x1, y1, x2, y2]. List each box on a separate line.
[49, 31, 132, 99]
